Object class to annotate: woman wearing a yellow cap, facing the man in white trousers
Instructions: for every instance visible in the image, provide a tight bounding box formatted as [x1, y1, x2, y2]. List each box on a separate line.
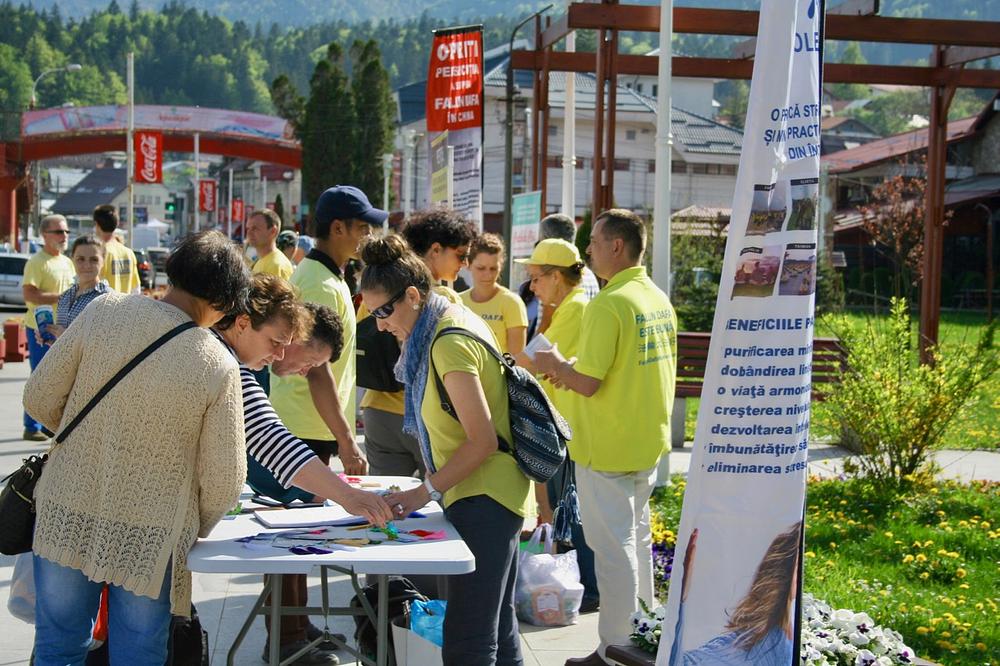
[514, 238, 600, 613]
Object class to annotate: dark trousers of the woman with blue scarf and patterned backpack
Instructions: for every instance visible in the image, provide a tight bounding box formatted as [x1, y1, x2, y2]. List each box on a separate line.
[442, 495, 524, 666]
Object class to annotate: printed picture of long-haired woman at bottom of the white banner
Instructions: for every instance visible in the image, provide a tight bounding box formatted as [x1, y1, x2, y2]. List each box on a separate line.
[668, 521, 802, 666]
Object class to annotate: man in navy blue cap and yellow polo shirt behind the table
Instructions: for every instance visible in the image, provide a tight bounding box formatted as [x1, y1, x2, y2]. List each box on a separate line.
[271, 185, 389, 474]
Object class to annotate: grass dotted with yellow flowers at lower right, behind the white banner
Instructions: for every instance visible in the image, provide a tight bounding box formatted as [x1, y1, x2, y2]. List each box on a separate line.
[653, 477, 1000, 666]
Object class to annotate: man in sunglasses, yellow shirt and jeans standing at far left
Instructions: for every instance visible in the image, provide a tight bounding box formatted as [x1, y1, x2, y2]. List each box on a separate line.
[21, 215, 76, 442]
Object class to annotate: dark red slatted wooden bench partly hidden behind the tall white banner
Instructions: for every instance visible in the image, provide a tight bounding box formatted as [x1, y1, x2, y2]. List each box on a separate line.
[671, 332, 847, 448]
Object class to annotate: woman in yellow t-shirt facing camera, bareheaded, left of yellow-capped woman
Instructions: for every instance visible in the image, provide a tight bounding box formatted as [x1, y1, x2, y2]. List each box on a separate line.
[460, 234, 528, 356]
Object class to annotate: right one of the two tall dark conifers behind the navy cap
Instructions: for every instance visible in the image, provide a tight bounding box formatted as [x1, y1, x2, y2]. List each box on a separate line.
[351, 39, 396, 208]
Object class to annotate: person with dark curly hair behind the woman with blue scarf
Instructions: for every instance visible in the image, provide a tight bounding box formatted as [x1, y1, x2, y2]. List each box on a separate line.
[358, 208, 476, 477]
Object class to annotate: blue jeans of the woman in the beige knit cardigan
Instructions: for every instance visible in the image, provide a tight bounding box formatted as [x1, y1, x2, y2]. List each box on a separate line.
[34, 555, 172, 666]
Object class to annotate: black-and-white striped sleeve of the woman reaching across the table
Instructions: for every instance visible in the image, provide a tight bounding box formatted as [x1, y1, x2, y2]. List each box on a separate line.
[212, 329, 316, 488]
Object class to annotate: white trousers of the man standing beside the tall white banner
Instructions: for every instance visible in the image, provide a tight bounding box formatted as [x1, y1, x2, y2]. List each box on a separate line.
[576, 465, 656, 657]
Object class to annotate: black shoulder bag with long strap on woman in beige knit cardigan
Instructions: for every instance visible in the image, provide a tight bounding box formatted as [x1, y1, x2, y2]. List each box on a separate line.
[0, 321, 197, 555]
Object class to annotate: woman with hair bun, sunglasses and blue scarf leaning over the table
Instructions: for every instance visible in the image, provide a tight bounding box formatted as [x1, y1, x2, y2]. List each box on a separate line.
[361, 236, 528, 665]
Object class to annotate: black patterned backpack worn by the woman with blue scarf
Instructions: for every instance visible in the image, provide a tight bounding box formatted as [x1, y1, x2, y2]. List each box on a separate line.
[431, 326, 573, 483]
